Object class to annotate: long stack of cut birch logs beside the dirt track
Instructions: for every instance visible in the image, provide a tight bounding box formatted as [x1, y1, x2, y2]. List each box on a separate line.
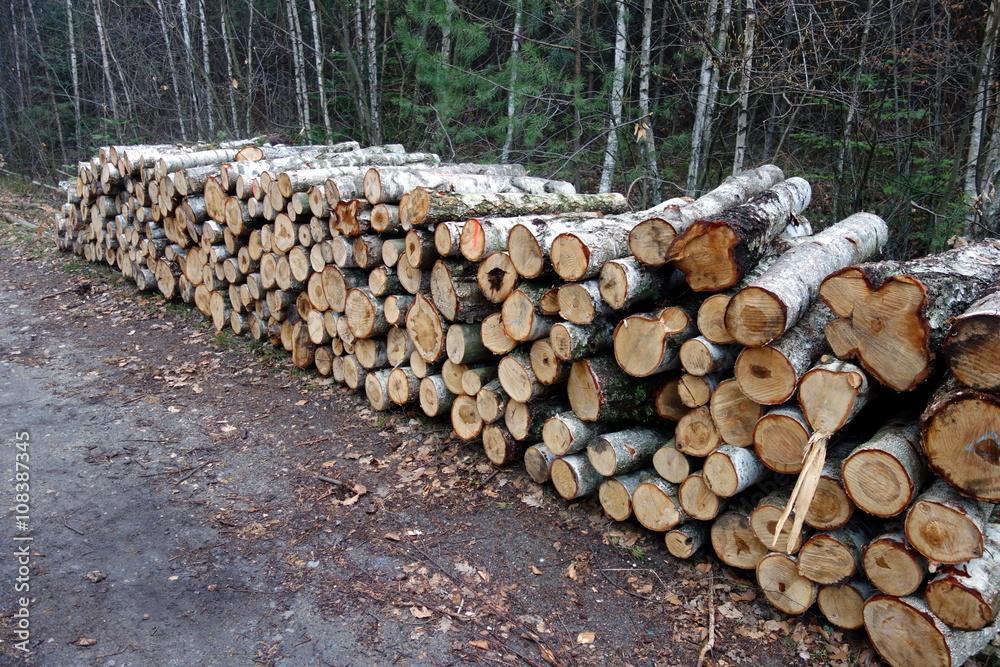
[58, 142, 1000, 665]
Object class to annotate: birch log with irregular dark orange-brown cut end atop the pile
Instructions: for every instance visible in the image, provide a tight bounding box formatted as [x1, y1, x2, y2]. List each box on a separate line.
[669, 177, 812, 291]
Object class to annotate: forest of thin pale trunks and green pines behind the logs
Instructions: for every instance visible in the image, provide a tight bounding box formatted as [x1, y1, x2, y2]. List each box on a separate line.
[0, 0, 1000, 257]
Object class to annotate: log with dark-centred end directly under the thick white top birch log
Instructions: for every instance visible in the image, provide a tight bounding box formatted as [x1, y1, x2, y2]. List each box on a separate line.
[733, 303, 834, 405]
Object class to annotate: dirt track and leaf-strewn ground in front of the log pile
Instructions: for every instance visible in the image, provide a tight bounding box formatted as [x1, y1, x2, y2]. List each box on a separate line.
[0, 183, 874, 667]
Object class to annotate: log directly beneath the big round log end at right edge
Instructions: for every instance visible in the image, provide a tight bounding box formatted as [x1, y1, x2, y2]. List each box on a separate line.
[905, 479, 993, 564]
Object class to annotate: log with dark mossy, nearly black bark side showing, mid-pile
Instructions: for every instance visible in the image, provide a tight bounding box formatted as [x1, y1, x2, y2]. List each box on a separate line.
[566, 356, 663, 421]
